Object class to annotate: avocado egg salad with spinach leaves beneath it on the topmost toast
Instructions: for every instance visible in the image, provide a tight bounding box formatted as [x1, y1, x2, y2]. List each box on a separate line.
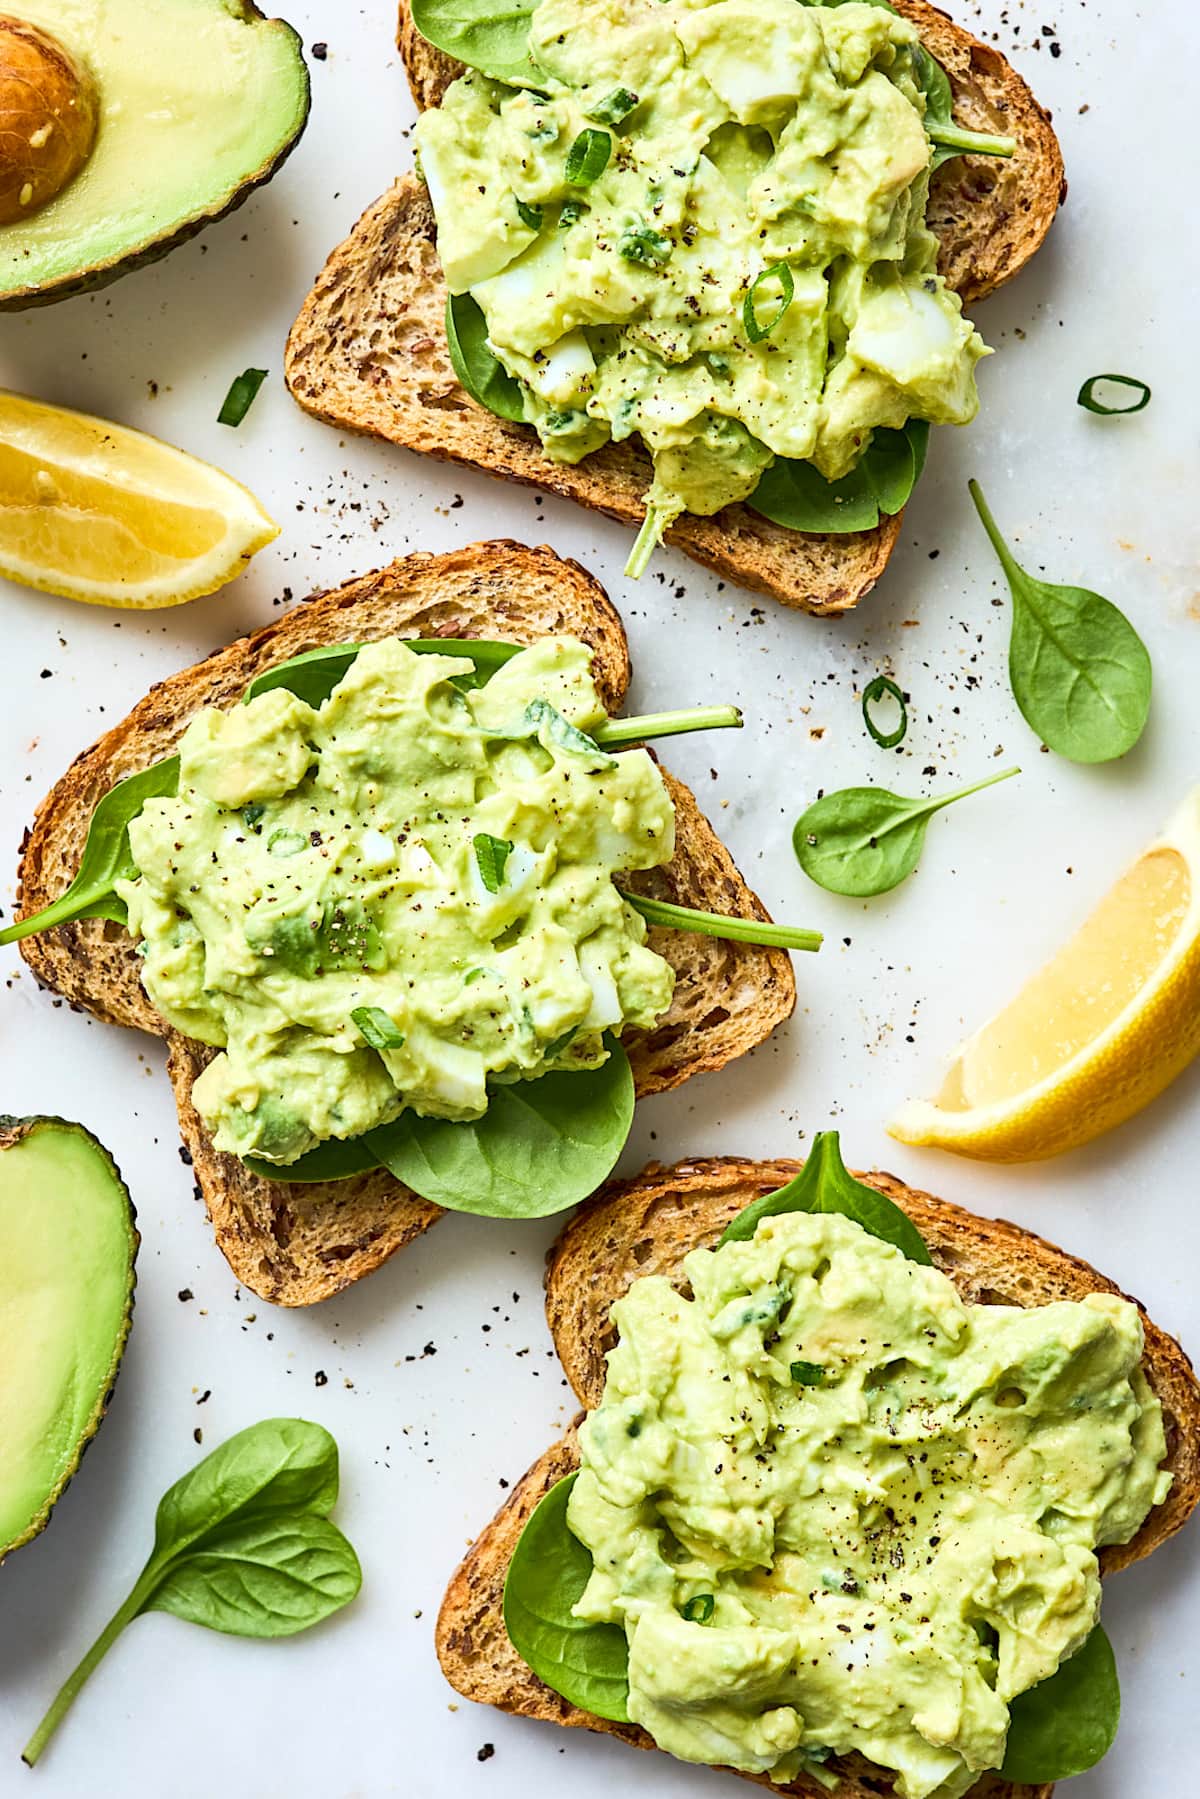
[414, 0, 1015, 574]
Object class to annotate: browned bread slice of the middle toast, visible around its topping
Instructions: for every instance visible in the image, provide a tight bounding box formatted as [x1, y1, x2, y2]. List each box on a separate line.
[20, 541, 795, 1306]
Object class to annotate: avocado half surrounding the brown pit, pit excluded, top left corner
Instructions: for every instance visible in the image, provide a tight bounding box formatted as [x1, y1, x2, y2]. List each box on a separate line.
[0, 0, 309, 311]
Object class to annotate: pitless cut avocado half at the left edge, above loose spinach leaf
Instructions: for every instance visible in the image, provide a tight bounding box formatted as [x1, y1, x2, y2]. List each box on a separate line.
[0, 1117, 139, 1562]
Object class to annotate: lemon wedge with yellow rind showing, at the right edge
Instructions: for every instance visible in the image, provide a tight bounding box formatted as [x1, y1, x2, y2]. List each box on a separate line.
[887, 788, 1200, 1162]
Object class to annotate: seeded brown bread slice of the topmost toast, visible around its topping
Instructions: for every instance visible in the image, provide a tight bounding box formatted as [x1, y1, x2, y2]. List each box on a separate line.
[284, 0, 1065, 613]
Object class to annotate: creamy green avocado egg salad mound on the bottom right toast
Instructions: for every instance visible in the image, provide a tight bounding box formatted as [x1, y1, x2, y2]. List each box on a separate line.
[569, 1214, 1171, 1799]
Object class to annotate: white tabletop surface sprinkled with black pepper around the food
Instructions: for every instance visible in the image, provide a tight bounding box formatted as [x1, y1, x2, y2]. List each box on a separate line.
[0, 0, 1200, 1799]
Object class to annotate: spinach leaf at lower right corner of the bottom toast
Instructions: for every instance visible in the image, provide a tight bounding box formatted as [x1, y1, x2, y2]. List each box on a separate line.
[1000, 1624, 1121, 1786]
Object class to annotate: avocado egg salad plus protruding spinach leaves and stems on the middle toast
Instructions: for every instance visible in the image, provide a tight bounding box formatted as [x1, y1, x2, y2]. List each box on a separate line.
[4, 637, 820, 1216]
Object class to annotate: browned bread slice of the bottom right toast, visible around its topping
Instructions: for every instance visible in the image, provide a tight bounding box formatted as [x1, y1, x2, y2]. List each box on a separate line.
[435, 1157, 1200, 1799]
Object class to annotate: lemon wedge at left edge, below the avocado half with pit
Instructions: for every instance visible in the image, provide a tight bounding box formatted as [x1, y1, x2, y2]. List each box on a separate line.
[0, 392, 279, 606]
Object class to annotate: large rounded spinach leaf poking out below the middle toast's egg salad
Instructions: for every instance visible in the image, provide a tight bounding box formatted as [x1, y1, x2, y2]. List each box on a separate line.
[368, 1038, 633, 1218]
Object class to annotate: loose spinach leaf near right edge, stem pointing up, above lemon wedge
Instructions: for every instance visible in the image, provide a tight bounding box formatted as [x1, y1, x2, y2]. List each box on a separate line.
[968, 480, 1153, 763]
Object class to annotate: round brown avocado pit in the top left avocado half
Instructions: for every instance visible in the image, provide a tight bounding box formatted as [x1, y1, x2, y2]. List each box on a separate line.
[0, 13, 99, 225]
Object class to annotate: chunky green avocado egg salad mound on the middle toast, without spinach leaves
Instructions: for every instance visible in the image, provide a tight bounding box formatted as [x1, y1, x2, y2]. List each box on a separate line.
[117, 637, 675, 1164]
